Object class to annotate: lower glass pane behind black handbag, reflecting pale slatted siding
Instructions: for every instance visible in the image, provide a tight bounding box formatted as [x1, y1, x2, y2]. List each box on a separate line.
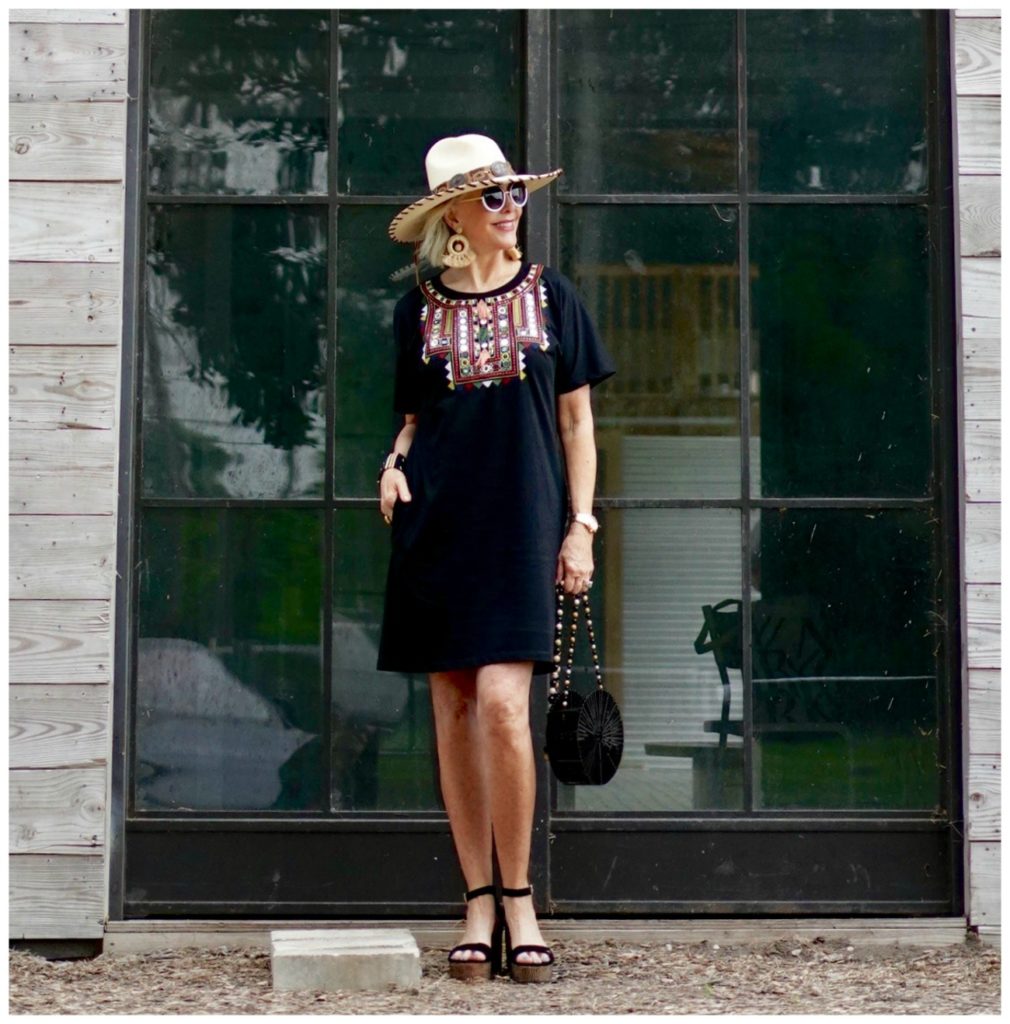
[557, 509, 744, 812]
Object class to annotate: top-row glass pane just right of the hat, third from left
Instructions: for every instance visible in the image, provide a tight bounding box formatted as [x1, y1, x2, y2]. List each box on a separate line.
[557, 10, 737, 193]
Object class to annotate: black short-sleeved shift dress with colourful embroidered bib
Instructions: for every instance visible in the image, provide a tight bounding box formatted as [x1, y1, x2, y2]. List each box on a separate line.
[378, 262, 615, 673]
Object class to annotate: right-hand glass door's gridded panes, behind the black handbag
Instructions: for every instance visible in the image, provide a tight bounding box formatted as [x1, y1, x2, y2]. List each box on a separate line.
[556, 10, 943, 813]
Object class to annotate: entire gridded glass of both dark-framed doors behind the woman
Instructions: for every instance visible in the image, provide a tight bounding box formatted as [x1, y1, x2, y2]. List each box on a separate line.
[131, 9, 949, 827]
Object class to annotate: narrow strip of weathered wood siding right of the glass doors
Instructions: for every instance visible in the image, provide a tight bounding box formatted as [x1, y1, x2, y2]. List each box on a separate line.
[954, 9, 1001, 935]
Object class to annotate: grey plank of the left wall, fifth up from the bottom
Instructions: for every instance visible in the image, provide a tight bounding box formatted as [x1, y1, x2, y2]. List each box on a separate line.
[8, 515, 116, 601]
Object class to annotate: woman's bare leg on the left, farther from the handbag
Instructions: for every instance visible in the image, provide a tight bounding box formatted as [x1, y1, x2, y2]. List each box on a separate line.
[428, 669, 495, 961]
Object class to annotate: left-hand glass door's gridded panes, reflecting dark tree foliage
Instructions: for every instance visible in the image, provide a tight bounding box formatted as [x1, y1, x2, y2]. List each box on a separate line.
[137, 10, 522, 814]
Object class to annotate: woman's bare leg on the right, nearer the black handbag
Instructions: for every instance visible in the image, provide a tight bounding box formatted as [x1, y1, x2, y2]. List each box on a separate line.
[476, 662, 547, 964]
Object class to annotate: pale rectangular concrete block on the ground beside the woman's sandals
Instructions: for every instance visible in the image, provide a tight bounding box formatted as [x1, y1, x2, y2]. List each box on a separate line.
[270, 928, 421, 992]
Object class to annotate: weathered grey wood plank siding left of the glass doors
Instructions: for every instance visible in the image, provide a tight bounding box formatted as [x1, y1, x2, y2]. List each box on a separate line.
[8, 10, 128, 939]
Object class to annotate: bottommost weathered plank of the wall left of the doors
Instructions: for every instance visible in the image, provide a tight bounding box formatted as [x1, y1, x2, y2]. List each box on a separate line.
[8, 854, 107, 939]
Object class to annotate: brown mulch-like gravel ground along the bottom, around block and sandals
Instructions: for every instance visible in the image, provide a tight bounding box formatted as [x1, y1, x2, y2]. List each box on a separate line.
[10, 937, 1000, 1014]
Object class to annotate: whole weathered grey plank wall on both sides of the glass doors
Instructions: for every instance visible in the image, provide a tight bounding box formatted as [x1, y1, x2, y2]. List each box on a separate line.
[9, 9, 1001, 938]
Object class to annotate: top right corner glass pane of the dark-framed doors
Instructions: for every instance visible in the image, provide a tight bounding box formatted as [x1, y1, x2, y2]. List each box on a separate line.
[747, 10, 929, 194]
